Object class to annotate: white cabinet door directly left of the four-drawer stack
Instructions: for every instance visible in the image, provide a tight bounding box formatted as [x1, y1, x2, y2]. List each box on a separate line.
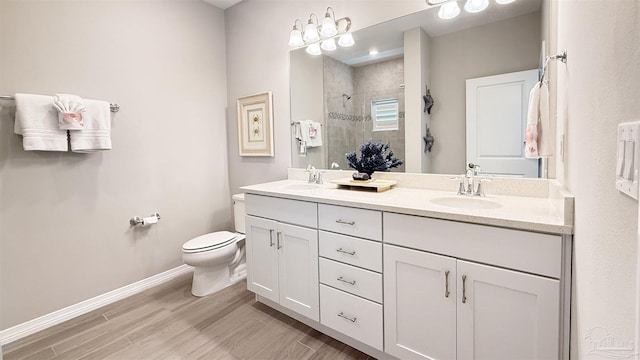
[276, 223, 320, 321]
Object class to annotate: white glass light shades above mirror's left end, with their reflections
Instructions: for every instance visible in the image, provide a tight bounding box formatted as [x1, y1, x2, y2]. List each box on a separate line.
[289, 7, 355, 55]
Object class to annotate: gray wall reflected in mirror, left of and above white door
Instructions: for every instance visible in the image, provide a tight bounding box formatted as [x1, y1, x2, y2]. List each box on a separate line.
[430, 12, 541, 174]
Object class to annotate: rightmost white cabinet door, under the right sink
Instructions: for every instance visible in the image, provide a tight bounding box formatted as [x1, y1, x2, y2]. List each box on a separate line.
[457, 260, 560, 360]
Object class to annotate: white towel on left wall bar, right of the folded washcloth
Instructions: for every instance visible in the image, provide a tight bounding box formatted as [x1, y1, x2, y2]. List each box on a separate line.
[69, 99, 111, 153]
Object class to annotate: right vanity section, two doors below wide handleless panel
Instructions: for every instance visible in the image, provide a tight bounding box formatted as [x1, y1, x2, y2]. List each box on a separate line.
[383, 213, 563, 359]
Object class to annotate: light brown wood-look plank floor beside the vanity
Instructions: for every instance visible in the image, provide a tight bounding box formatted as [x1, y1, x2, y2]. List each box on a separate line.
[3, 276, 373, 360]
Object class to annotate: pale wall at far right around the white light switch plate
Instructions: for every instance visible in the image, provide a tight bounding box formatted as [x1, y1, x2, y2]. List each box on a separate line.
[558, 0, 640, 359]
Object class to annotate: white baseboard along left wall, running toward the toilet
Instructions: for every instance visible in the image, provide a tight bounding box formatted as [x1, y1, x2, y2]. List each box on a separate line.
[0, 265, 193, 346]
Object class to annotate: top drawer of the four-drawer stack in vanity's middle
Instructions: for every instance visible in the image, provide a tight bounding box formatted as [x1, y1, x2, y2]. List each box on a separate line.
[318, 204, 382, 241]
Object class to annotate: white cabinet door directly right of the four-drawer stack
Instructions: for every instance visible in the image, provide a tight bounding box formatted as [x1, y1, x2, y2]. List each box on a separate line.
[383, 245, 462, 360]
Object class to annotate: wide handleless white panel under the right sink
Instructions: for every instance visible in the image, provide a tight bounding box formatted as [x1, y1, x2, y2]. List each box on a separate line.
[384, 213, 562, 279]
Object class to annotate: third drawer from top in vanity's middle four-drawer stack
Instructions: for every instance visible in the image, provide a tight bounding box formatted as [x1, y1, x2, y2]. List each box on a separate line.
[320, 258, 382, 303]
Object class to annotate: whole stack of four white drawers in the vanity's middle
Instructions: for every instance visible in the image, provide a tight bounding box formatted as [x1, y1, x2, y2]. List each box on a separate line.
[318, 204, 383, 351]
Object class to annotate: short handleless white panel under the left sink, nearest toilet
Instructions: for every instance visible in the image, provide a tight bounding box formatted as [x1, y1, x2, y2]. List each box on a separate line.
[244, 194, 318, 228]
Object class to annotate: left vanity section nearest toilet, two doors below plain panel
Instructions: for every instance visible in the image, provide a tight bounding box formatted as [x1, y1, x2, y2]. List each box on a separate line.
[245, 194, 319, 321]
